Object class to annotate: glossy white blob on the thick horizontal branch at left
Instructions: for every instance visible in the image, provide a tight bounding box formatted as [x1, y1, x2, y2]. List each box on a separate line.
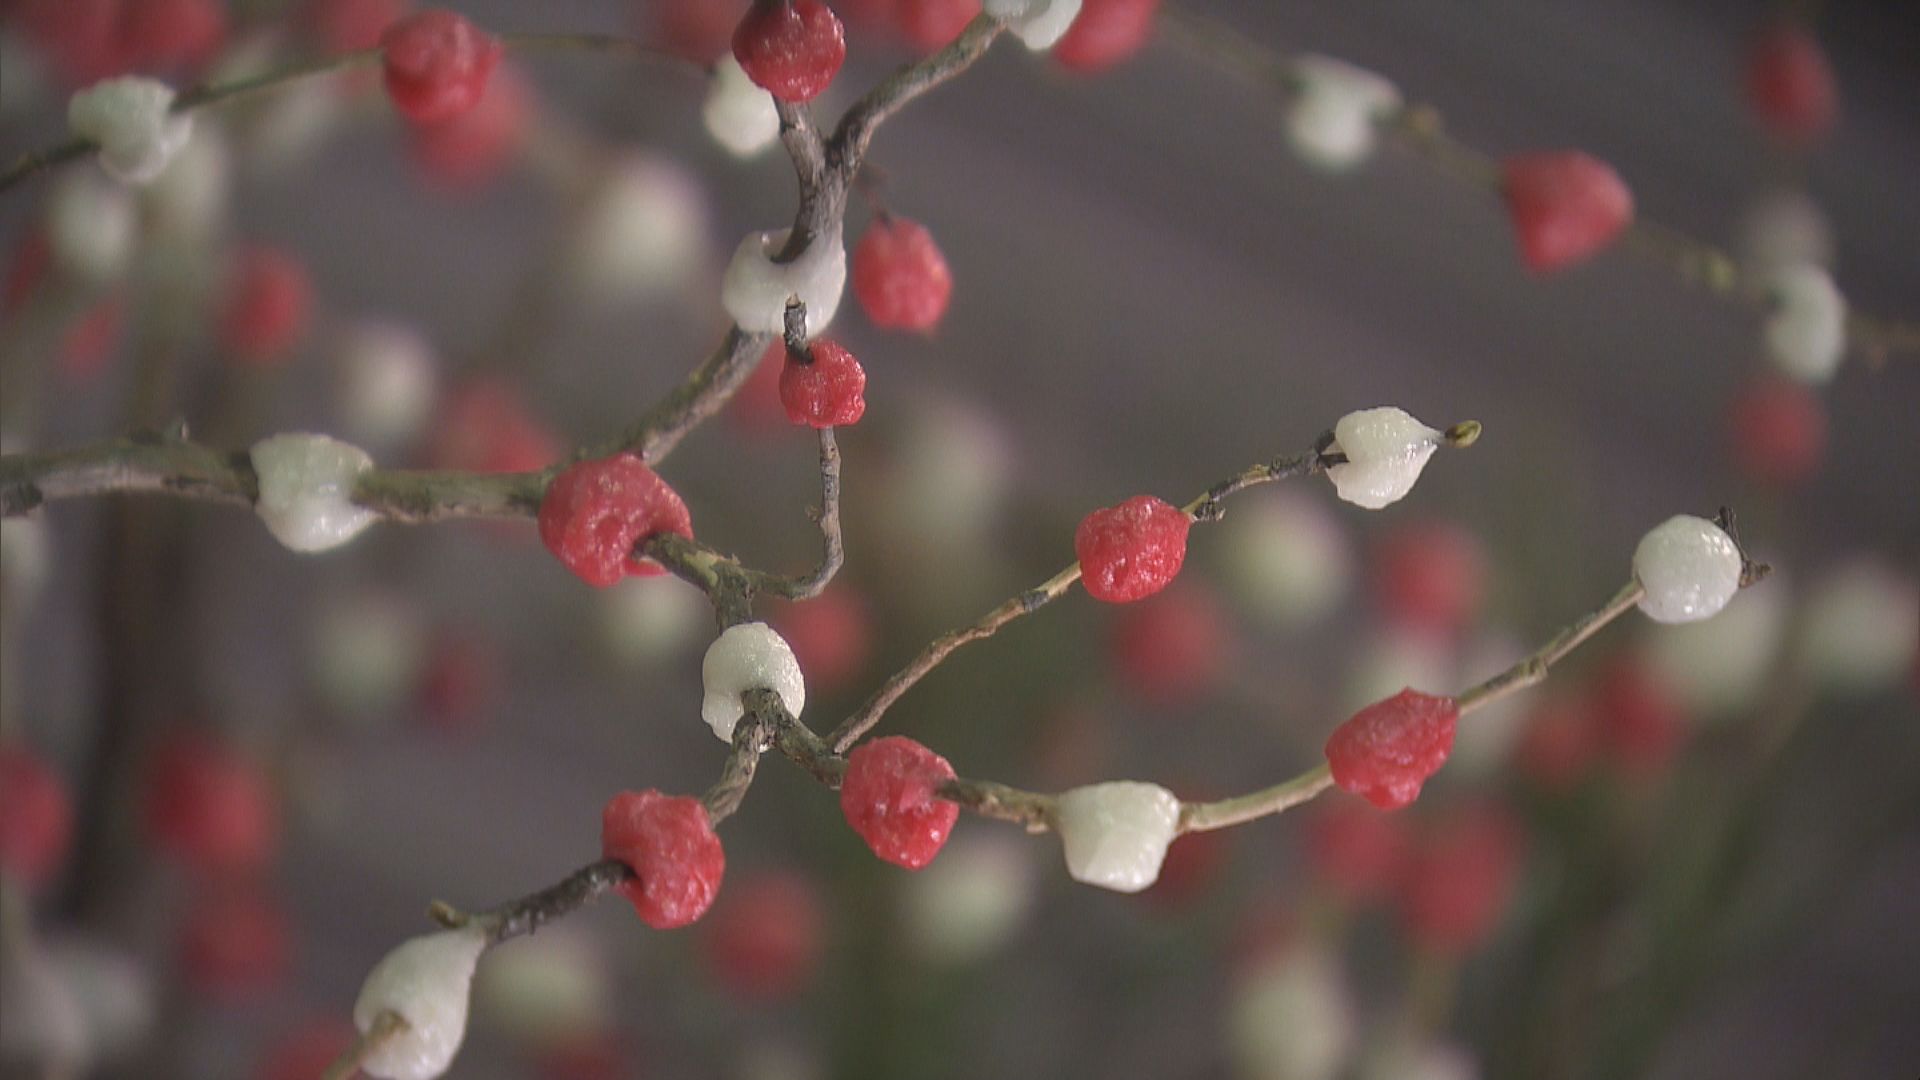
[250, 432, 378, 552]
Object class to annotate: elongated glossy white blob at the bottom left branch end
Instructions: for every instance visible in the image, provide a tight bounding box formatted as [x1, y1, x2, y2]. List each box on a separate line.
[353, 928, 486, 1080]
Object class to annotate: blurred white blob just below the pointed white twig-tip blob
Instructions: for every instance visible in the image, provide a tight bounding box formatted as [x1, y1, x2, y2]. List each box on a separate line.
[1219, 490, 1354, 628]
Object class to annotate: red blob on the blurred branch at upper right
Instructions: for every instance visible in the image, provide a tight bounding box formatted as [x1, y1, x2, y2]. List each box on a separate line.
[1500, 150, 1634, 273]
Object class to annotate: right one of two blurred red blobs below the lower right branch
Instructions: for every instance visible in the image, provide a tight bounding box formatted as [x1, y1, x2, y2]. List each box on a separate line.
[1400, 803, 1526, 955]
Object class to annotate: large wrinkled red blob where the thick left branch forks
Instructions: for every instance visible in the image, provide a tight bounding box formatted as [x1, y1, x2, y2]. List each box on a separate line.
[540, 454, 693, 588]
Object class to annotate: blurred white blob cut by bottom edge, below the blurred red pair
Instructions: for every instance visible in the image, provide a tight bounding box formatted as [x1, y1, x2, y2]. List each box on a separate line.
[1227, 944, 1356, 1080]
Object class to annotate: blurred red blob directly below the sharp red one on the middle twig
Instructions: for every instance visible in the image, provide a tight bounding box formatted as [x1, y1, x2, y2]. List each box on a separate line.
[1112, 584, 1233, 705]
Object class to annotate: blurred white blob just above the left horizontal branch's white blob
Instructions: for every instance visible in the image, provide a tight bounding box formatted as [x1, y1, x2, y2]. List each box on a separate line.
[334, 321, 440, 446]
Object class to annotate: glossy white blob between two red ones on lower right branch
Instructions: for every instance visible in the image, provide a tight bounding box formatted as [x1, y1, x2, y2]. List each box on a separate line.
[1054, 780, 1181, 892]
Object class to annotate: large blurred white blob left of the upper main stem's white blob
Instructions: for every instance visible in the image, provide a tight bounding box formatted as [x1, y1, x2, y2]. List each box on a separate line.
[568, 152, 710, 304]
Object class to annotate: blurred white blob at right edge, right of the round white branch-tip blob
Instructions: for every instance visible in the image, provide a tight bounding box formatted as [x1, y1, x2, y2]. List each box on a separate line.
[1801, 555, 1920, 694]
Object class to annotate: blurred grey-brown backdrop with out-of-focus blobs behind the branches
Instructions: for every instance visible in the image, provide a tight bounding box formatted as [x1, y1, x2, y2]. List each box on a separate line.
[0, 0, 1920, 1080]
